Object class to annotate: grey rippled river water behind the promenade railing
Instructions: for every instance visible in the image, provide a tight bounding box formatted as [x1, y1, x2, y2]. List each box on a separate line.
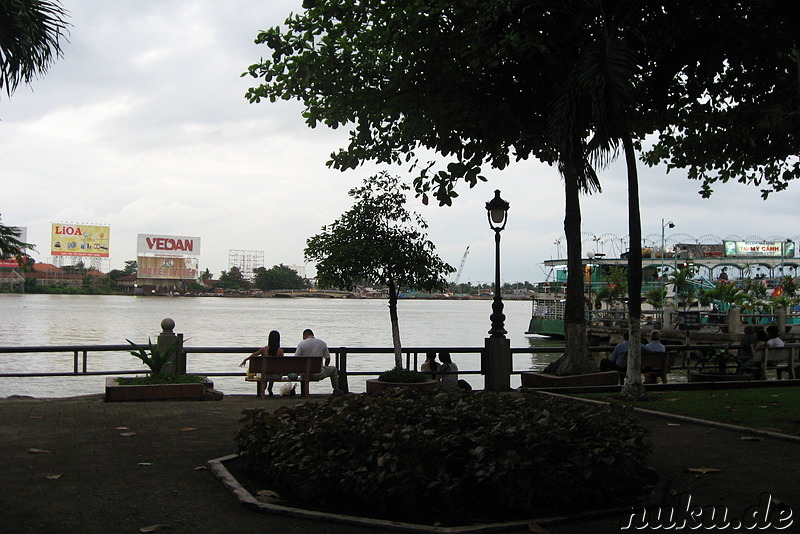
[0, 294, 558, 397]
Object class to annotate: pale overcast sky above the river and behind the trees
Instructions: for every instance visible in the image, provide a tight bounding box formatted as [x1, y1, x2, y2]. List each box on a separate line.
[0, 0, 800, 283]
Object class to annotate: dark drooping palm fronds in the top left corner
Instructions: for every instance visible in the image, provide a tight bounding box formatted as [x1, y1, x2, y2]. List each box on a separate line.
[0, 0, 67, 96]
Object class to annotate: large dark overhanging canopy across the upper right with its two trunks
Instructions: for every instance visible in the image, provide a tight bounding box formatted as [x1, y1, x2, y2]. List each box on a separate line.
[245, 0, 800, 386]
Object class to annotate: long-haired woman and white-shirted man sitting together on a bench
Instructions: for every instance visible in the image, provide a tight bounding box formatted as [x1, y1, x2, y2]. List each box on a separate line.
[244, 328, 342, 397]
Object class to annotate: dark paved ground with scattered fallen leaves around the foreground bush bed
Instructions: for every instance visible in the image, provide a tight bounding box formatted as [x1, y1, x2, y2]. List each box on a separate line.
[0, 396, 800, 534]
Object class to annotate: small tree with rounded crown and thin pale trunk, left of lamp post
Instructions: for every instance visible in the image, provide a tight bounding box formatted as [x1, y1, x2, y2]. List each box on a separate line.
[305, 172, 455, 367]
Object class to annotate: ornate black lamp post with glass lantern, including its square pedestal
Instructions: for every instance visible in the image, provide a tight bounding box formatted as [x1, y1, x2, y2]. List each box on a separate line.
[481, 189, 512, 391]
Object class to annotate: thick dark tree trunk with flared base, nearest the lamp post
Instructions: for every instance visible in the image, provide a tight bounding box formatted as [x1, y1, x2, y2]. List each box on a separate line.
[548, 165, 597, 375]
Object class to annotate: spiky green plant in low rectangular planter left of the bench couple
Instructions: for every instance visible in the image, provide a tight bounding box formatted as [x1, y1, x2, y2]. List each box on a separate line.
[106, 338, 222, 402]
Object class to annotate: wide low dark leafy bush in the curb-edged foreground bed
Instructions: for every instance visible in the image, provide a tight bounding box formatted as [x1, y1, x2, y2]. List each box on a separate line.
[236, 389, 650, 524]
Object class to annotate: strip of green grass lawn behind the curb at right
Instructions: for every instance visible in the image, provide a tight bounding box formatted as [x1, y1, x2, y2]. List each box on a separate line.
[576, 387, 800, 436]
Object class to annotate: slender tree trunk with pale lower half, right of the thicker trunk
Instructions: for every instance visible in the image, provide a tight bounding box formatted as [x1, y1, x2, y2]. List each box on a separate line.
[622, 136, 645, 400]
